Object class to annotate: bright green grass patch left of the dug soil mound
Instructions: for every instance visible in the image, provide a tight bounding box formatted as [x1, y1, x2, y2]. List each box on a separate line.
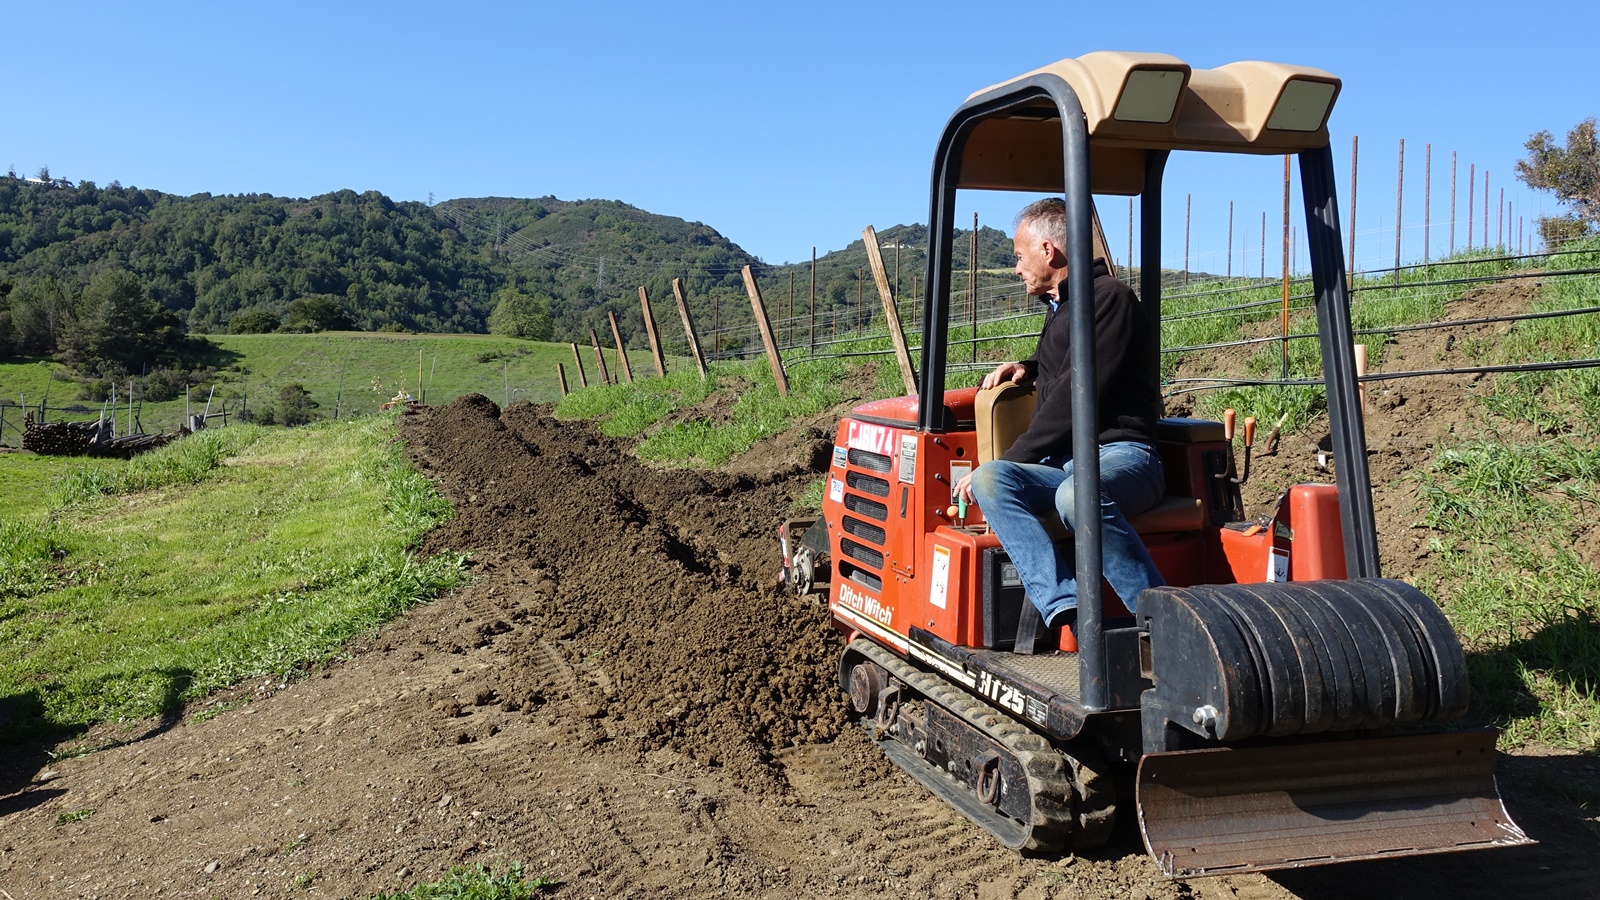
[0, 416, 462, 737]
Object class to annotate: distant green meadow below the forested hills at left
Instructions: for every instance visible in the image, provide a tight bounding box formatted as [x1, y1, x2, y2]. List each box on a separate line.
[0, 331, 656, 447]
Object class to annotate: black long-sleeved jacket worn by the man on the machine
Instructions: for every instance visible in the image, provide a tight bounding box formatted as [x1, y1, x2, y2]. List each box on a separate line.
[1003, 259, 1162, 463]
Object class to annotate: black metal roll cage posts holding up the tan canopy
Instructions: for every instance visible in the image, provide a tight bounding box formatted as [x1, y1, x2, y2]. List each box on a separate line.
[917, 72, 1379, 711]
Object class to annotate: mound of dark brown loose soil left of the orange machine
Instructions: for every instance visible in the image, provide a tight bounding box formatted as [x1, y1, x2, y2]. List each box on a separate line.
[405, 396, 843, 790]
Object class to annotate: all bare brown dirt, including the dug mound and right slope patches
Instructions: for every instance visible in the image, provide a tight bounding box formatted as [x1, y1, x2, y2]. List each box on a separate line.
[0, 277, 1600, 900]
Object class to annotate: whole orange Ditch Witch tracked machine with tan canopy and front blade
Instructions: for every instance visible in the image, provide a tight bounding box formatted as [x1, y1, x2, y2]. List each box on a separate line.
[781, 53, 1528, 878]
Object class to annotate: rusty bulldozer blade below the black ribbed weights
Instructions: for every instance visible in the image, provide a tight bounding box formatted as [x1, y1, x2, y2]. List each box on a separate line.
[1138, 730, 1534, 878]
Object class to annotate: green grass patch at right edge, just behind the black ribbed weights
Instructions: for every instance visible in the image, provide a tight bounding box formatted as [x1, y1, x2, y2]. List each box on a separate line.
[1418, 439, 1600, 749]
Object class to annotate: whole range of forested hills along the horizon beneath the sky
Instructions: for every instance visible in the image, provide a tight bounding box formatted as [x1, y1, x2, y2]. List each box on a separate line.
[0, 176, 1010, 352]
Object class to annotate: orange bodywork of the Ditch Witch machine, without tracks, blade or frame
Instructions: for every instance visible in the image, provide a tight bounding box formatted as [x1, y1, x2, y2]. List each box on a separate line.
[822, 388, 1344, 653]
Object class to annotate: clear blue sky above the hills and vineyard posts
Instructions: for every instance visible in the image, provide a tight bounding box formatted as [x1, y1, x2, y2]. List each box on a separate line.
[0, 0, 1600, 272]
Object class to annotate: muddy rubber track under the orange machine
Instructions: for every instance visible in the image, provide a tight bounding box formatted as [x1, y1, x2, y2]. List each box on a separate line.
[846, 639, 1117, 854]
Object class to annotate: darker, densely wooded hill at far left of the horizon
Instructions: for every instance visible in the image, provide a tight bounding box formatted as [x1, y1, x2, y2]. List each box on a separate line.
[0, 178, 504, 333]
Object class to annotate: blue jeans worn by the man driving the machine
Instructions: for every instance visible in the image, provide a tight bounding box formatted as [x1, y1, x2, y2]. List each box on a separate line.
[973, 442, 1166, 623]
